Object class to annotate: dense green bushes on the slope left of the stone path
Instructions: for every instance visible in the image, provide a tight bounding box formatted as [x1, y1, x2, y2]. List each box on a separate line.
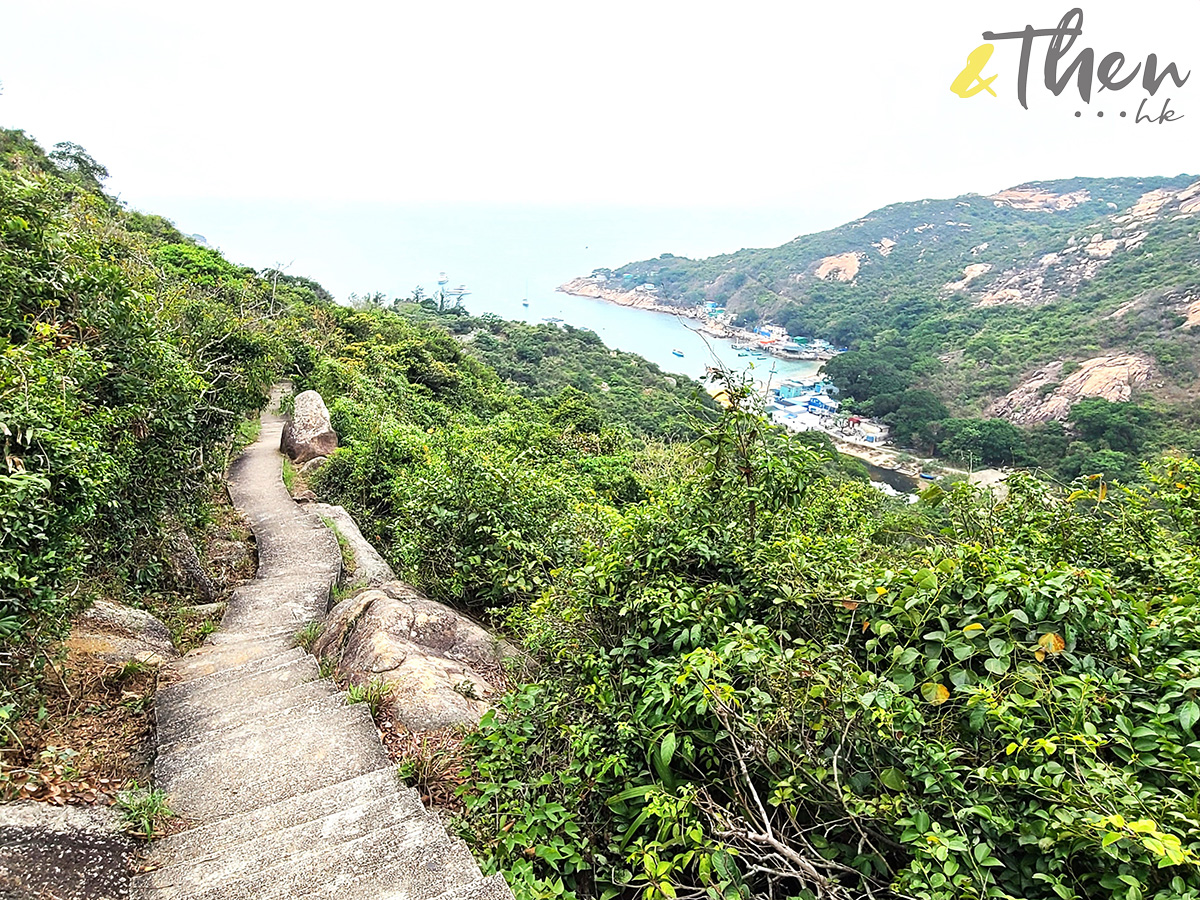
[0, 131, 288, 724]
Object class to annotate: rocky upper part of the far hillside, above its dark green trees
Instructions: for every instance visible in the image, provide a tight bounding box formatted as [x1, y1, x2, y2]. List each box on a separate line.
[564, 175, 1200, 434]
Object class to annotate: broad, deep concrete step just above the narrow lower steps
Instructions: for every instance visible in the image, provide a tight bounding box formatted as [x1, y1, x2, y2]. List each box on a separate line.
[157, 703, 389, 826]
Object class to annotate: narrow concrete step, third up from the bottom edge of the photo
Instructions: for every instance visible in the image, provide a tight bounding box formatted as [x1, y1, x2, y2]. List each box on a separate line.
[142, 764, 405, 868]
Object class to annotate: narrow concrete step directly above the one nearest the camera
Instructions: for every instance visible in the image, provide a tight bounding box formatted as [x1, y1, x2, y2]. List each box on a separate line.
[143, 793, 442, 900]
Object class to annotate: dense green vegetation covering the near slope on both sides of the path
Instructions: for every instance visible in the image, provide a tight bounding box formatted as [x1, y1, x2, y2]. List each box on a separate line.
[7, 132, 1200, 900]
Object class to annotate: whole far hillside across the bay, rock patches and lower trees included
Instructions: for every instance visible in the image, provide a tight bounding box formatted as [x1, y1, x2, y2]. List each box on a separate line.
[580, 175, 1200, 480]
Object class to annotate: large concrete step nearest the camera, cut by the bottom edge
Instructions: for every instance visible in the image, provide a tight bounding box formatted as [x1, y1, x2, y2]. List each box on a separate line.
[131, 823, 480, 900]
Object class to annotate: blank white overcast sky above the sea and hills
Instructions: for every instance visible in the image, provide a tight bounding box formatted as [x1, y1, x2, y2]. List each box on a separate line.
[0, 0, 1200, 218]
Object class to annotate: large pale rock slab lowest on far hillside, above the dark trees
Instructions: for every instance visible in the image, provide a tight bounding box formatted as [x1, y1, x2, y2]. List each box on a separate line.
[988, 354, 1154, 425]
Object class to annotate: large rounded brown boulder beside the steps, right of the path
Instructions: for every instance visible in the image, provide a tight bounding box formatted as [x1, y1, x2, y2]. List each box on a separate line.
[313, 581, 515, 731]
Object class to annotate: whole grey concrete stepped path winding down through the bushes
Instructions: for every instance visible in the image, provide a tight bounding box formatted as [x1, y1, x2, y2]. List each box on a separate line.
[131, 398, 512, 900]
